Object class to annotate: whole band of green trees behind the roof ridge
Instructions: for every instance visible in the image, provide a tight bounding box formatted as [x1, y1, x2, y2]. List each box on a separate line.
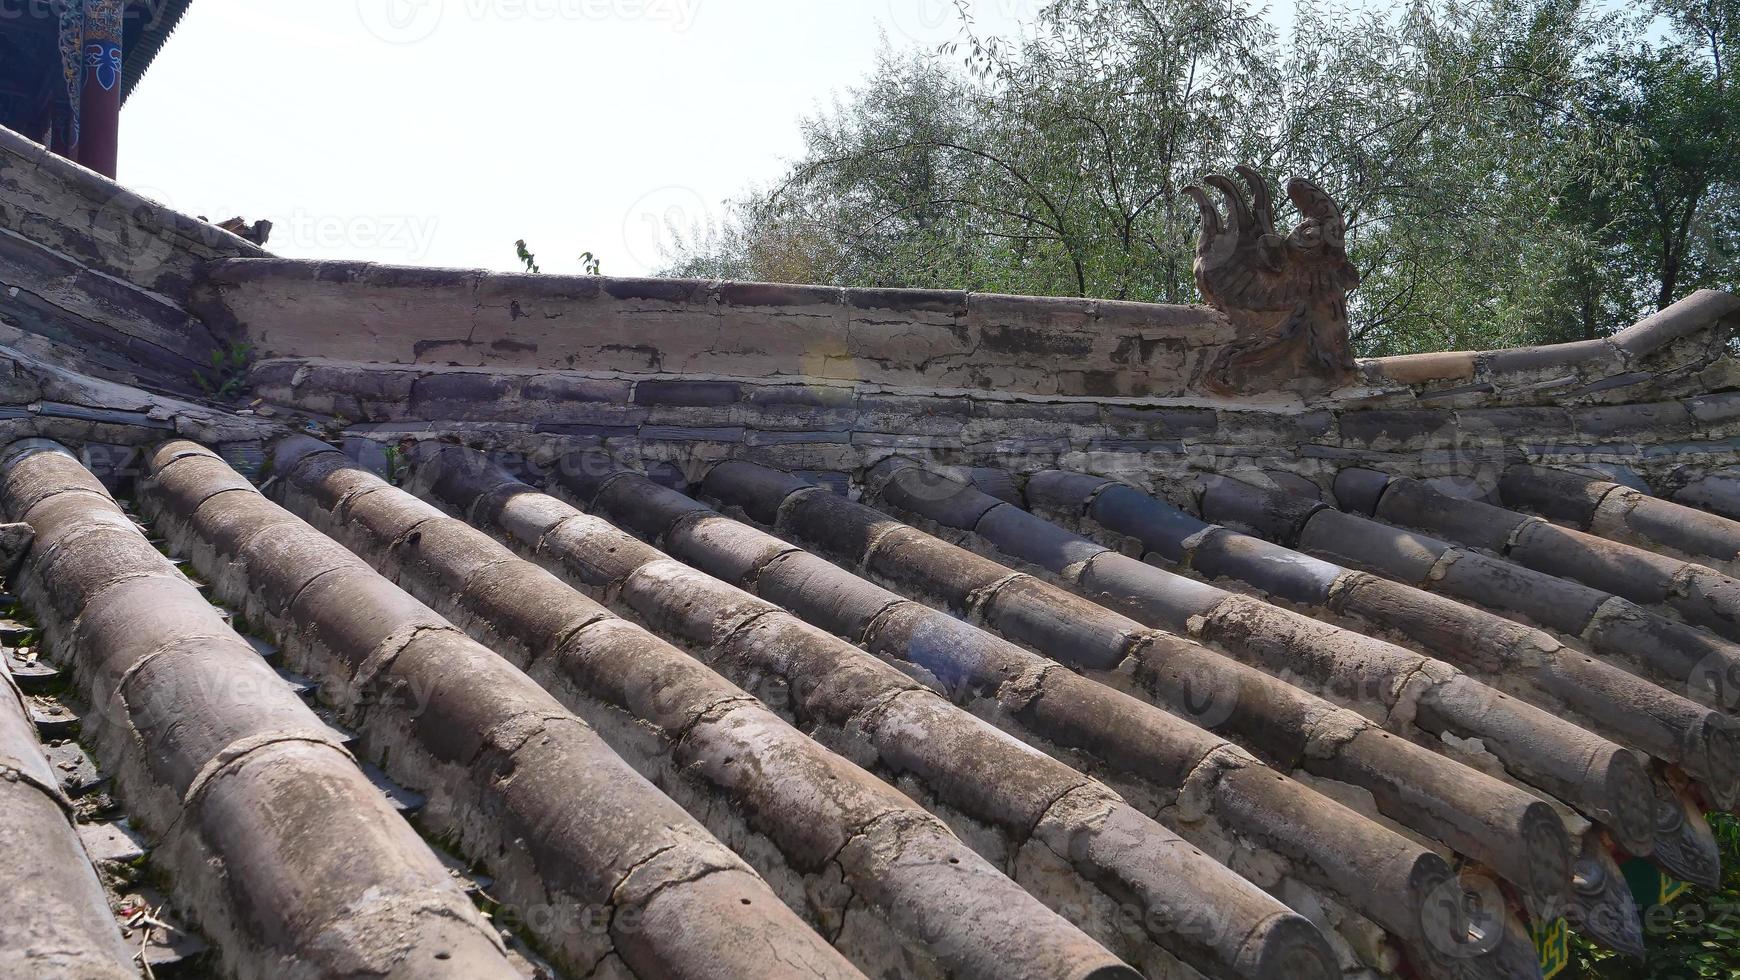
[665, 0, 1740, 353]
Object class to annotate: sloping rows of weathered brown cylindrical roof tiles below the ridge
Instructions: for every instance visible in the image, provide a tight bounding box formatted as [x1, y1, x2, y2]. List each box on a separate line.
[0, 439, 1740, 978]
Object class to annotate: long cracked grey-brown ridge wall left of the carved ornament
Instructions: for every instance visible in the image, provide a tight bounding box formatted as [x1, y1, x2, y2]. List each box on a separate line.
[200, 259, 1232, 397]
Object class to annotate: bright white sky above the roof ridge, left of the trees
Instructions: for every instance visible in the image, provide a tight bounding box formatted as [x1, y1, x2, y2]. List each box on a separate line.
[120, 0, 1042, 275]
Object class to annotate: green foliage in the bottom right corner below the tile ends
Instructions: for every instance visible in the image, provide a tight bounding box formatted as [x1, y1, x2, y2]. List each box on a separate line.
[1573, 813, 1740, 980]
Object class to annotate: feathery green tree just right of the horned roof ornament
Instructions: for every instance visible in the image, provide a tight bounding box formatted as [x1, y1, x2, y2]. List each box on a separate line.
[1275, 0, 1620, 353]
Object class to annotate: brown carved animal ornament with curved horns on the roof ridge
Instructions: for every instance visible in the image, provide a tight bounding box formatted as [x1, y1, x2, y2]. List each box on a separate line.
[1185, 165, 1359, 393]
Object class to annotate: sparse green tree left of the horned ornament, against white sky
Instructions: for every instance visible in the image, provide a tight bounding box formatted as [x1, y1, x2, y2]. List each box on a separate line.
[673, 0, 1275, 301]
